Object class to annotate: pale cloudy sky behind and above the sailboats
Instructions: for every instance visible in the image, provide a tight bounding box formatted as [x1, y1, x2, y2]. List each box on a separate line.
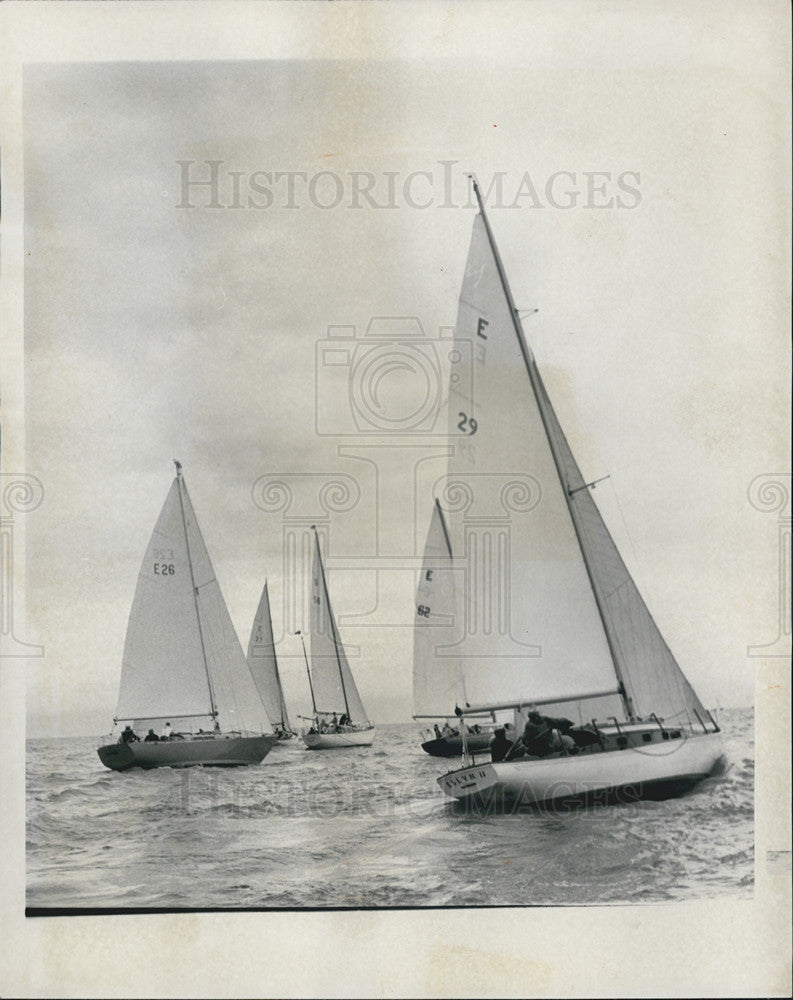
[15, 27, 789, 736]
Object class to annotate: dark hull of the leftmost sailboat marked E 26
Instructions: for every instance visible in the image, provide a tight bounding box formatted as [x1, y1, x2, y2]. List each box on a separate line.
[97, 735, 278, 771]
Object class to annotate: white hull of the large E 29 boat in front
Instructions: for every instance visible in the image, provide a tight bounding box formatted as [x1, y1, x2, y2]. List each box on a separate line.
[438, 733, 721, 805]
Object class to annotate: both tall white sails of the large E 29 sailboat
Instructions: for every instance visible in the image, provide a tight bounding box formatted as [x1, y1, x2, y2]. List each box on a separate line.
[446, 184, 706, 721]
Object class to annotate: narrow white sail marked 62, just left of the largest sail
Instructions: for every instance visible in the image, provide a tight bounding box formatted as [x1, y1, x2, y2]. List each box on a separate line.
[413, 500, 465, 717]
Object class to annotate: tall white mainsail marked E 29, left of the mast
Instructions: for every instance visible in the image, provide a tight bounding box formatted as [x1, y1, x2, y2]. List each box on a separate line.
[444, 215, 620, 712]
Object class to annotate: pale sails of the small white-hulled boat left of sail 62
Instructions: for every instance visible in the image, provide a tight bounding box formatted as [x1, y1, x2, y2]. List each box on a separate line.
[311, 532, 369, 726]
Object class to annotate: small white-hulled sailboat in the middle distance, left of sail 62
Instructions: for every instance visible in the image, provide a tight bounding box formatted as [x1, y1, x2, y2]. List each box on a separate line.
[300, 525, 375, 750]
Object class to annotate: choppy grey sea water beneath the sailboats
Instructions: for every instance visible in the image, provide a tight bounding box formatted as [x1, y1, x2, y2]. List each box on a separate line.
[27, 709, 754, 912]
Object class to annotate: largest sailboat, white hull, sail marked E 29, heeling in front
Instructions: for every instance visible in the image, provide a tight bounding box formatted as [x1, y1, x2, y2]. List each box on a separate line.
[438, 181, 721, 804]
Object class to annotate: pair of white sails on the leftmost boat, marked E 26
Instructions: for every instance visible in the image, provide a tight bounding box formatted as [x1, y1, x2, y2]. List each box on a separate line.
[116, 465, 269, 732]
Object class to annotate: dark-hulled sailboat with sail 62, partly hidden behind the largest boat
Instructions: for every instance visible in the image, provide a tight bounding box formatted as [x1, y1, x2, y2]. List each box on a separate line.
[413, 499, 493, 757]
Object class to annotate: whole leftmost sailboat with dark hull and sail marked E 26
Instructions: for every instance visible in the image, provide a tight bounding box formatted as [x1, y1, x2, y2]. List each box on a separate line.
[97, 462, 277, 771]
